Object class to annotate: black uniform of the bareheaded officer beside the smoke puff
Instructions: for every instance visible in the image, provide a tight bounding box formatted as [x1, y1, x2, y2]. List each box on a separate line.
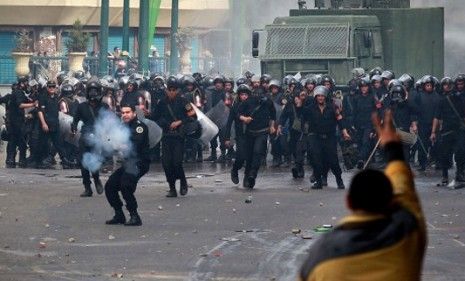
[105, 117, 150, 218]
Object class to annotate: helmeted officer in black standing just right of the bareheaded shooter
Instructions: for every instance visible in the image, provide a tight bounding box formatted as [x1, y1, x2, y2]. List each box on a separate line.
[154, 76, 195, 197]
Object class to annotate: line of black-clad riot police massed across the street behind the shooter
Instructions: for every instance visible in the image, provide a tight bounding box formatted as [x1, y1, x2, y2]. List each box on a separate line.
[0, 67, 465, 190]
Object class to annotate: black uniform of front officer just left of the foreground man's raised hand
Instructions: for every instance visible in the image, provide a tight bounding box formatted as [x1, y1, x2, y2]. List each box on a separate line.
[303, 102, 345, 188]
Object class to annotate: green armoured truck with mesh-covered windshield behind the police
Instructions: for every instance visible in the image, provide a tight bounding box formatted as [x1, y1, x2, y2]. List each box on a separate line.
[252, 0, 444, 85]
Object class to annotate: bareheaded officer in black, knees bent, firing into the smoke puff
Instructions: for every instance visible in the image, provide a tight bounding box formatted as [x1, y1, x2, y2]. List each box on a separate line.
[105, 104, 150, 226]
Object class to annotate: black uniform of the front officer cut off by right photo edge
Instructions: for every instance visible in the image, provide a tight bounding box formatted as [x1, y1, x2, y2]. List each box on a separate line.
[435, 94, 465, 179]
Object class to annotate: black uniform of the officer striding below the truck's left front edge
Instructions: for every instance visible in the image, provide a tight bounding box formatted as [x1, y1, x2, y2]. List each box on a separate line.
[238, 95, 276, 188]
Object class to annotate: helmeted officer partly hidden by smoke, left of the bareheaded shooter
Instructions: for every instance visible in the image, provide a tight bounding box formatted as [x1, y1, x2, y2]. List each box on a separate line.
[71, 80, 109, 197]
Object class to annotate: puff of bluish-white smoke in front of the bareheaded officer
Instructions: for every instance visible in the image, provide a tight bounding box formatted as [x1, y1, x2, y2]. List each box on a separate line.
[82, 110, 133, 172]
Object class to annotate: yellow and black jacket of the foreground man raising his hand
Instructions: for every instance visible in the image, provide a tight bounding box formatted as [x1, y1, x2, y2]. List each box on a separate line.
[300, 144, 426, 281]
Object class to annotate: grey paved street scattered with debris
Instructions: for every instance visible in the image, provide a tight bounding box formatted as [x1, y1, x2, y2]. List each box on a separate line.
[0, 161, 465, 281]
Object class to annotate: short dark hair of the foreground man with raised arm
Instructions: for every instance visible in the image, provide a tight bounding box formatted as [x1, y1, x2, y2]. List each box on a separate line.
[348, 169, 393, 213]
